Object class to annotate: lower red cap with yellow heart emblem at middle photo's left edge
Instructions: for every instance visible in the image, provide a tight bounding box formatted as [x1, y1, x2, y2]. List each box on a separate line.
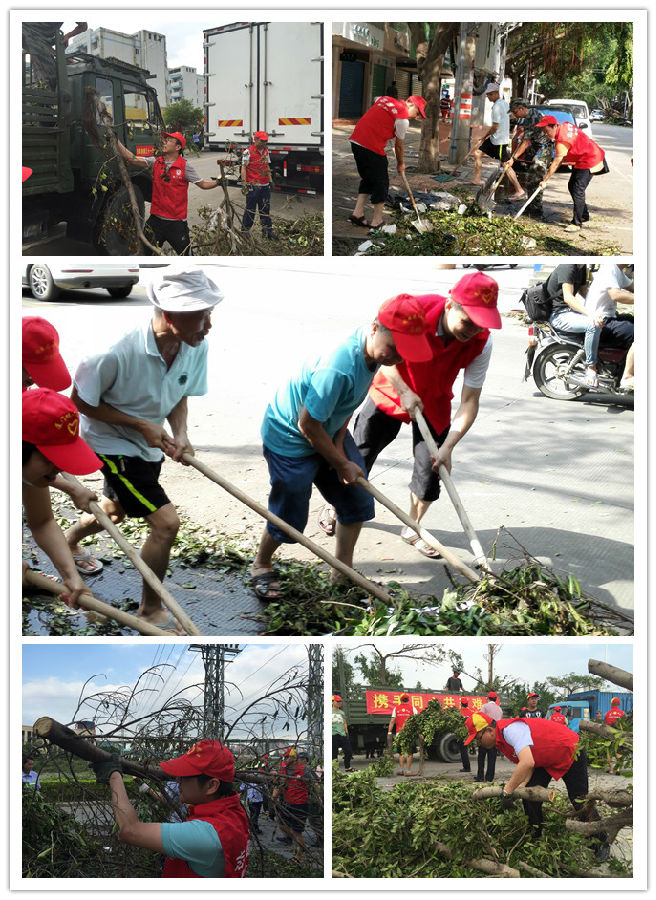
[23, 388, 102, 475]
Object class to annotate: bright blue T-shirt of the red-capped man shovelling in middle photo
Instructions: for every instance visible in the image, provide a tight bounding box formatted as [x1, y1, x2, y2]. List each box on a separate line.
[260, 328, 378, 458]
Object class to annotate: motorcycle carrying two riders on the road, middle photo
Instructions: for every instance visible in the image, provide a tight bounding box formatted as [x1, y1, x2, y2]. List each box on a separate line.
[524, 322, 628, 400]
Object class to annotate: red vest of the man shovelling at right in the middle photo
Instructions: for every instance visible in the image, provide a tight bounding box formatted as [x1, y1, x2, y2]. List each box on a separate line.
[369, 294, 490, 434]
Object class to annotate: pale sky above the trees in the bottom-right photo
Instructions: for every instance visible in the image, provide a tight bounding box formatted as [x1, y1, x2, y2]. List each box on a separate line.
[342, 638, 633, 691]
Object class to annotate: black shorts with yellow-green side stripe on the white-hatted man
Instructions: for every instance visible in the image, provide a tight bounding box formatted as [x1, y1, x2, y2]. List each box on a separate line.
[97, 453, 171, 518]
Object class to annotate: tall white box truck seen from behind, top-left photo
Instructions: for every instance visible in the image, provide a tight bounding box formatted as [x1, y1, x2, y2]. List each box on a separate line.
[203, 22, 324, 194]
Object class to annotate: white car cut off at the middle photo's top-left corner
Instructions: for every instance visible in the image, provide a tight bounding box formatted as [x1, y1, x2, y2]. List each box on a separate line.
[23, 257, 139, 300]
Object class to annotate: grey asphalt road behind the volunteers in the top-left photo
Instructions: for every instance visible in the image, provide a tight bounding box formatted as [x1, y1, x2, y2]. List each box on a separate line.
[23, 152, 323, 256]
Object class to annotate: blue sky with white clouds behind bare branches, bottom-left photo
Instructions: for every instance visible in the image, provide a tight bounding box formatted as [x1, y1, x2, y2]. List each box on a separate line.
[22, 641, 307, 736]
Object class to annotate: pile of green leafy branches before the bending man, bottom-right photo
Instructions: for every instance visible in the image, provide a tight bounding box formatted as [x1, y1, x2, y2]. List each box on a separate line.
[333, 767, 627, 878]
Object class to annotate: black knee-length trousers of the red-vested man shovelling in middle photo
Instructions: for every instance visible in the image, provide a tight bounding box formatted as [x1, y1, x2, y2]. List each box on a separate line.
[353, 397, 451, 502]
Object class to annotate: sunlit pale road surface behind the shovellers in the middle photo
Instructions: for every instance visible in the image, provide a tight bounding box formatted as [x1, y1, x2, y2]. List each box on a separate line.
[21, 259, 646, 624]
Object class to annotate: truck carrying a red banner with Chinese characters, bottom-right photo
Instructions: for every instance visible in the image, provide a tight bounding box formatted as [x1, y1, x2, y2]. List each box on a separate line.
[339, 686, 487, 762]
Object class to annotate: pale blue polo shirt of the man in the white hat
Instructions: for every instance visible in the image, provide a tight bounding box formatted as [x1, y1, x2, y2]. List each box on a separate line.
[75, 320, 207, 462]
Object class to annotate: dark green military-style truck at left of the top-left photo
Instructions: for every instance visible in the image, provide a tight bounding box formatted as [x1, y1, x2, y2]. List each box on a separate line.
[22, 22, 164, 255]
